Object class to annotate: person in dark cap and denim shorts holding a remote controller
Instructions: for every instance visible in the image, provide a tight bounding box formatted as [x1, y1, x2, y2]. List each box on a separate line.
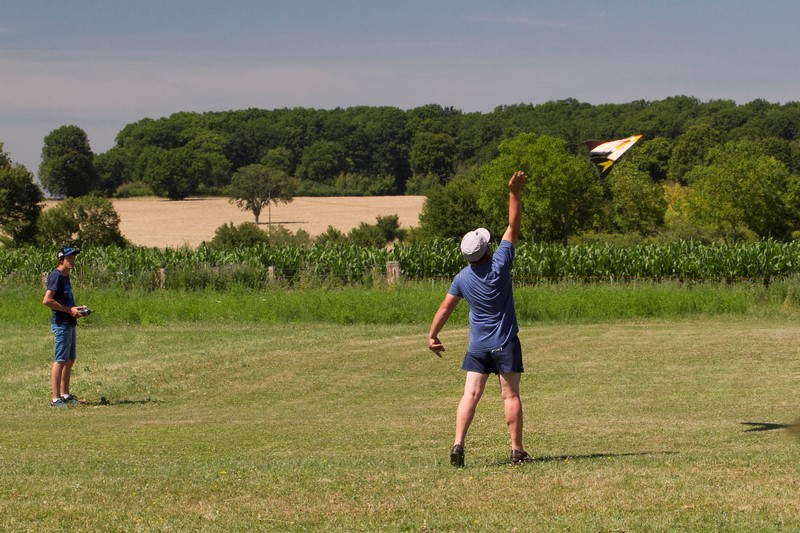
[42, 247, 86, 407]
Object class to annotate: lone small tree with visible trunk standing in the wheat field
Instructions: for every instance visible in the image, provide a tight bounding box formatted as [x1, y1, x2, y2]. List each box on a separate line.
[230, 165, 296, 224]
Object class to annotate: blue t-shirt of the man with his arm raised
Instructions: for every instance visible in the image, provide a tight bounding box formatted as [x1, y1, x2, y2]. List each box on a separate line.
[447, 241, 519, 352]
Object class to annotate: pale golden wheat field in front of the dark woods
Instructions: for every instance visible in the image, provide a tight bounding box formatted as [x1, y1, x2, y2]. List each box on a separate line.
[47, 196, 425, 248]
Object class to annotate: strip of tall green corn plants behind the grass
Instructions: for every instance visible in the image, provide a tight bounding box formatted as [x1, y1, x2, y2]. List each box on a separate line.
[0, 240, 800, 290]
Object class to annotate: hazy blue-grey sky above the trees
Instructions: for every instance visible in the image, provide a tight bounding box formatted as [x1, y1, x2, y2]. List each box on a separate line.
[0, 0, 800, 173]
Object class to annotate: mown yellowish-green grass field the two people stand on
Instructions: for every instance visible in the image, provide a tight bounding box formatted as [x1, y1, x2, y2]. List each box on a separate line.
[0, 286, 800, 531]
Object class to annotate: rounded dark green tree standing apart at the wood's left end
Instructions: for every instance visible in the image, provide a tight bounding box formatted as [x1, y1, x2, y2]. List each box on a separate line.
[39, 125, 98, 198]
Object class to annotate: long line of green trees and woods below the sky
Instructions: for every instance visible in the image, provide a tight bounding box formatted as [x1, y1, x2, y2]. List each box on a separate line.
[0, 96, 800, 245]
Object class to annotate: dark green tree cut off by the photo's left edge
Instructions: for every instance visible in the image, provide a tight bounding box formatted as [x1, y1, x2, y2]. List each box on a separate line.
[0, 143, 44, 245]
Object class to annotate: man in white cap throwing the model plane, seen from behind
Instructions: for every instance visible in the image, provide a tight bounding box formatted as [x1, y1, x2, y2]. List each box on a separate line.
[428, 172, 531, 467]
